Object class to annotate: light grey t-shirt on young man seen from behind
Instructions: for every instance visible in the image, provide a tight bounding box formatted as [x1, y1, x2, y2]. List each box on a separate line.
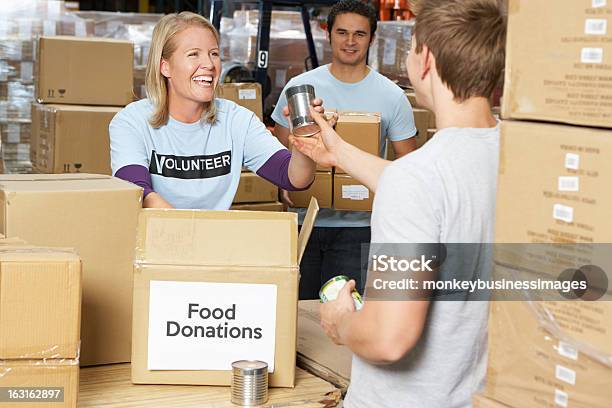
[345, 126, 499, 408]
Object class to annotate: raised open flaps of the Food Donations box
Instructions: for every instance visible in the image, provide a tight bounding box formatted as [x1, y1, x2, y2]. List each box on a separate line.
[136, 200, 318, 267]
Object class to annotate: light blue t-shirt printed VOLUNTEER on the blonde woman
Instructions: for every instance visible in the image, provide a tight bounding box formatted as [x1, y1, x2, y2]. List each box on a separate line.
[109, 98, 285, 210]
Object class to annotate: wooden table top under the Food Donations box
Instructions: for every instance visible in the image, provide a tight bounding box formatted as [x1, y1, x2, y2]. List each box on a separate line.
[78, 364, 340, 408]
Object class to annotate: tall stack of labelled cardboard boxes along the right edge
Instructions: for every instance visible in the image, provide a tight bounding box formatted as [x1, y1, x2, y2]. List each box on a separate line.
[475, 0, 612, 408]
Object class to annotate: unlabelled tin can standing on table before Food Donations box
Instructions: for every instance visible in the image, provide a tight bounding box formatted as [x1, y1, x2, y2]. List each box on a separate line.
[231, 360, 268, 407]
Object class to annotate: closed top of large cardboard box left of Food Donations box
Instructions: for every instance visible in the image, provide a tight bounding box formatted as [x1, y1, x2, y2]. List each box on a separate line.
[0, 173, 141, 193]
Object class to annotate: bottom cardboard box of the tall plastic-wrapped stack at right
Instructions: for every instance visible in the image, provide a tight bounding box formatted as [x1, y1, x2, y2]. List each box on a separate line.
[485, 301, 612, 408]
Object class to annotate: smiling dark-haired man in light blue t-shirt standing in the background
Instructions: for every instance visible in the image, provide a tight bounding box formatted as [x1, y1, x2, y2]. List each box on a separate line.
[272, 0, 417, 299]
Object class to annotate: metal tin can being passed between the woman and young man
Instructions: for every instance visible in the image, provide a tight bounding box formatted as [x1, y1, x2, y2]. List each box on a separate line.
[285, 84, 320, 137]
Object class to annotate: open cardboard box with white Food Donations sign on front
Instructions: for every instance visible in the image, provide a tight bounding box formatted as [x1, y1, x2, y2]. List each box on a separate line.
[132, 200, 318, 387]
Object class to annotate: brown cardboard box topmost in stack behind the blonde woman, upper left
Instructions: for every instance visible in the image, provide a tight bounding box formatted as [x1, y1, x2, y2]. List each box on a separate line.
[35, 36, 134, 106]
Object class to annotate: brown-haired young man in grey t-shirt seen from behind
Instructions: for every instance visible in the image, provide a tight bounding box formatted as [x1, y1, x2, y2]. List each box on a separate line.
[292, 0, 506, 408]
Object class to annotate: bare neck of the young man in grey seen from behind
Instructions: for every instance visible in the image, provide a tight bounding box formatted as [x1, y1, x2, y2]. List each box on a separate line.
[433, 96, 497, 129]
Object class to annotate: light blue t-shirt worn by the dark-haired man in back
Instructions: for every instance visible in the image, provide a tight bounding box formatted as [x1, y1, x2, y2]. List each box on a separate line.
[272, 65, 417, 227]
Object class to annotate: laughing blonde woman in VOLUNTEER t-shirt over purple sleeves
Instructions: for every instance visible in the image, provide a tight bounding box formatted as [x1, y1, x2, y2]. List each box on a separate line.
[109, 12, 322, 210]
